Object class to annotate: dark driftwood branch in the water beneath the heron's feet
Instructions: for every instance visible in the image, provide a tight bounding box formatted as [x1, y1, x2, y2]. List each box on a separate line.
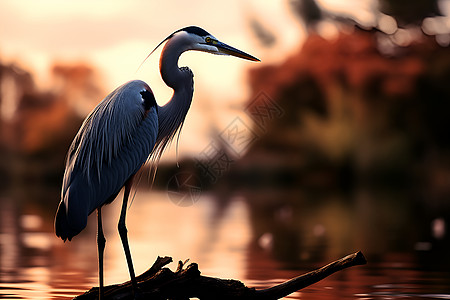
[75, 252, 366, 300]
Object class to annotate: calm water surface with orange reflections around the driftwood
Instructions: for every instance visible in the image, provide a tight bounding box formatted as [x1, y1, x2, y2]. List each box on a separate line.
[0, 190, 450, 299]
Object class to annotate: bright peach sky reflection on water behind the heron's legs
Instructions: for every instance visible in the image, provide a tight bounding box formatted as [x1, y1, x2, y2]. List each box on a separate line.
[67, 191, 251, 284]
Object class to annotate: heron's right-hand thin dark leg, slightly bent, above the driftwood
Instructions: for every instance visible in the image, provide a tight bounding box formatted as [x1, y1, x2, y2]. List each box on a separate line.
[118, 177, 137, 295]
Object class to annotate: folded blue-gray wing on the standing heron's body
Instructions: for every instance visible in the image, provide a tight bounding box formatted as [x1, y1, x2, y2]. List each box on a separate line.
[57, 80, 158, 239]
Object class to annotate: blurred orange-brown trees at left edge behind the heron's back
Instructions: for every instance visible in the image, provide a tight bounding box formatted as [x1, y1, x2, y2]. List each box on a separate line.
[0, 62, 103, 183]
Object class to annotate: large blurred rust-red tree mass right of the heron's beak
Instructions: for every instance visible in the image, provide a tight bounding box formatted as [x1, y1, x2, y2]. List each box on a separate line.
[243, 30, 450, 188]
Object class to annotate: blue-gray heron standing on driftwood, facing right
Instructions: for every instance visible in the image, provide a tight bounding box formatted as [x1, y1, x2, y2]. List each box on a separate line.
[55, 26, 259, 299]
